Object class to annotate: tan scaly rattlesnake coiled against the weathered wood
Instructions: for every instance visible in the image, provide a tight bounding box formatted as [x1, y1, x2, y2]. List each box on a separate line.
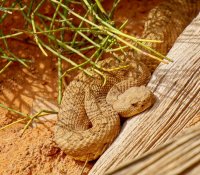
[54, 0, 200, 161]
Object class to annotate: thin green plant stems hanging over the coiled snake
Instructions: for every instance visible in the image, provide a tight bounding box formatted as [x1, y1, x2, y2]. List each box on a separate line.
[0, 0, 170, 131]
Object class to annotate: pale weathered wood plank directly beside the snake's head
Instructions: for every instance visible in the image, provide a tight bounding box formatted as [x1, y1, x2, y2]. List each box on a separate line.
[89, 14, 200, 175]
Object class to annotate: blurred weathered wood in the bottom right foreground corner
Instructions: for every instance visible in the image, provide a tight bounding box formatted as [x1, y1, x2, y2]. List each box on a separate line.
[106, 121, 200, 175]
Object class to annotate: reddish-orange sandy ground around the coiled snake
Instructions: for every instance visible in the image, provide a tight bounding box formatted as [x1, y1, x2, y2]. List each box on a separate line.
[0, 0, 160, 175]
